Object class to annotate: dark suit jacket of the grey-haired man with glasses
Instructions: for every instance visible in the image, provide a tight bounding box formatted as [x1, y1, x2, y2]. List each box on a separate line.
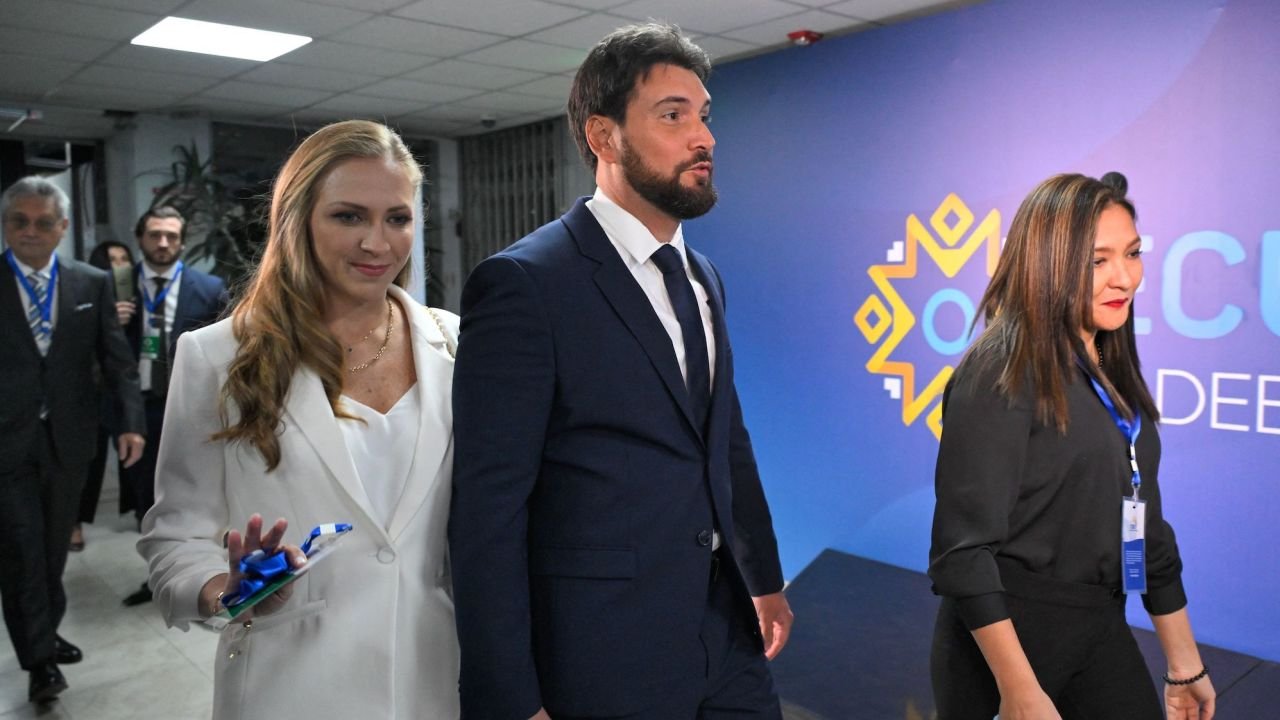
[0, 259, 146, 471]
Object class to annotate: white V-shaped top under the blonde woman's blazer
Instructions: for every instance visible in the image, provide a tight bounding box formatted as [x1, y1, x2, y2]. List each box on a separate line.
[338, 383, 421, 528]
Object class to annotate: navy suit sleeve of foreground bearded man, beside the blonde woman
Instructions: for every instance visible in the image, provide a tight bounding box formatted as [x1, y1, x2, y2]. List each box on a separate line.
[449, 256, 556, 720]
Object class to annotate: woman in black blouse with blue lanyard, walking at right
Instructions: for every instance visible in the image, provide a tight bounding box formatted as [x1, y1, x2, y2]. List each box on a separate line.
[929, 173, 1215, 720]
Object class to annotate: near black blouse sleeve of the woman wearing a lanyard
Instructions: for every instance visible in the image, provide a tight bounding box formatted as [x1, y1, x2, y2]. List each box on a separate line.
[929, 365, 1032, 630]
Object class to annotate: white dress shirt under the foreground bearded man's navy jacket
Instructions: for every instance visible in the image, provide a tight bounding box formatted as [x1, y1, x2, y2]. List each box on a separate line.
[586, 188, 716, 387]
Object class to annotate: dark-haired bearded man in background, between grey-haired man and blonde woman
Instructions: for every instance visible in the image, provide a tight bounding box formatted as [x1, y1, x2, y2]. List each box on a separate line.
[120, 205, 227, 606]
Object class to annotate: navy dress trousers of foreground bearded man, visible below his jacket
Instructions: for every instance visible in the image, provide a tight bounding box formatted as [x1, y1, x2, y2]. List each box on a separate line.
[550, 553, 778, 720]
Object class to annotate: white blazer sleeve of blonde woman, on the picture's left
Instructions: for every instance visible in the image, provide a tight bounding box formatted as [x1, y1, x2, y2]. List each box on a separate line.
[138, 334, 229, 629]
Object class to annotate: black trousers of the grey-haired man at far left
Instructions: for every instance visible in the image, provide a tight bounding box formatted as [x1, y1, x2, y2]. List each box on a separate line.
[0, 421, 86, 670]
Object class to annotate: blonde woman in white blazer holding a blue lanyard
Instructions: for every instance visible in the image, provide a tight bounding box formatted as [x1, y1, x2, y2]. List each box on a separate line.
[138, 120, 458, 719]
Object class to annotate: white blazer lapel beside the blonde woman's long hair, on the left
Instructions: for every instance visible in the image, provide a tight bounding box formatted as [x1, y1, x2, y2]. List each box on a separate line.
[285, 368, 380, 532]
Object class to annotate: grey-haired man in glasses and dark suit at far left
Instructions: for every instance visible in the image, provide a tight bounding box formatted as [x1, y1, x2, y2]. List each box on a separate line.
[0, 176, 145, 702]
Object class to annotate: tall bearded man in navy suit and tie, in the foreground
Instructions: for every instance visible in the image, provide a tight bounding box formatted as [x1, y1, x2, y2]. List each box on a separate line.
[449, 24, 792, 720]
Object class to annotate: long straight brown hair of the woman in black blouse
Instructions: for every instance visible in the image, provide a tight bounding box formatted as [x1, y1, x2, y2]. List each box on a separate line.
[964, 173, 1160, 433]
